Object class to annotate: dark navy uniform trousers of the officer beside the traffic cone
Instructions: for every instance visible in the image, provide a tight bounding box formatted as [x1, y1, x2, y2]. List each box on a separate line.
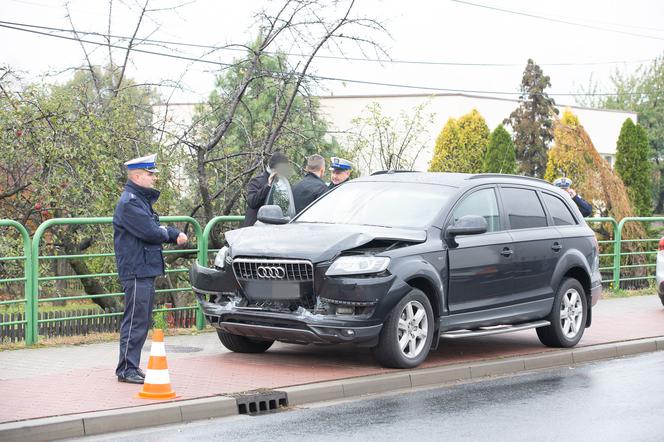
[115, 278, 154, 376]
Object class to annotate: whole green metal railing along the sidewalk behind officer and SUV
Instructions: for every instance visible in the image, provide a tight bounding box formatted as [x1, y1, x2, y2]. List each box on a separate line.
[0, 216, 664, 345]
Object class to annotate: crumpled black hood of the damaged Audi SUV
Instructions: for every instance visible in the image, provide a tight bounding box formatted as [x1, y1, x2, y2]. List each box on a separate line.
[226, 223, 426, 263]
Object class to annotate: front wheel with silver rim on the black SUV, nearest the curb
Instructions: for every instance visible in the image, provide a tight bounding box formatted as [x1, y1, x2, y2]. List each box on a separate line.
[373, 289, 435, 368]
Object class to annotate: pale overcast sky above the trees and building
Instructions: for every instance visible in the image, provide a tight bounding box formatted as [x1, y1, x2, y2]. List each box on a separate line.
[0, 0, 664, 104]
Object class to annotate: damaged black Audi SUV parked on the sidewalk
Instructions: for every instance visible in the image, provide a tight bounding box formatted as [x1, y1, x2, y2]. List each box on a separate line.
[190, 172, 602, 368]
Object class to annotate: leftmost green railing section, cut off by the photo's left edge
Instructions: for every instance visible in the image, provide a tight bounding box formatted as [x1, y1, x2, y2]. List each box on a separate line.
[0, 223, 34, 344]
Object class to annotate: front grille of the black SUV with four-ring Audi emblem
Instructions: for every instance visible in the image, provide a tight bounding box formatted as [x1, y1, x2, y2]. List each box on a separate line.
[233, 258, 314, 282]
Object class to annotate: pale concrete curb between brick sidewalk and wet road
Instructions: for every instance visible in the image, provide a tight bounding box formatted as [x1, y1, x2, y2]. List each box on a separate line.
[0, 337, 664, 442]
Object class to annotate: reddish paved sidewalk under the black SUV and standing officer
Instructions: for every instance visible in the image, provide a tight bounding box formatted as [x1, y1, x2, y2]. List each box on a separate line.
[0, 296, 664, 422]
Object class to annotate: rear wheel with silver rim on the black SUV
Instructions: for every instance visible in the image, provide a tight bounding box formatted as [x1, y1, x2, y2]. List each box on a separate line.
[537, 278, 588, 348]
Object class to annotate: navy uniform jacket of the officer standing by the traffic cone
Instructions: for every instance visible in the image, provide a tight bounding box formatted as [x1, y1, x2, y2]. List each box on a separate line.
[113, 181, 180, 281]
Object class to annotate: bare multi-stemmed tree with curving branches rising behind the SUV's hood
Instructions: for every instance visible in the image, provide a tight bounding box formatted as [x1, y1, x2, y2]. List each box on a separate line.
[177, 0, 387, 226]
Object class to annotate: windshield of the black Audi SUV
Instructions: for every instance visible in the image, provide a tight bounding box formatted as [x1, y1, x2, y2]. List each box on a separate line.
[293, 181, 453, 229]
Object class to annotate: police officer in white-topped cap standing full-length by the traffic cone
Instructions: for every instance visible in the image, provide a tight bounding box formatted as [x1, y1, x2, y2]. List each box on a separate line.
[113, 155, 187, 384]
